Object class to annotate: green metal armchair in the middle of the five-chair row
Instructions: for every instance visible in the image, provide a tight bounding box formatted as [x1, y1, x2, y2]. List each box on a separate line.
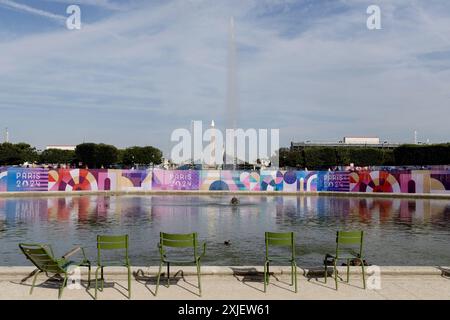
[155, 232, 206, 296]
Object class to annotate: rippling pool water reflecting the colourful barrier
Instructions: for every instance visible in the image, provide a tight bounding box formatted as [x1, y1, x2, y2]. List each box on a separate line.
[0, 195, 450, 267]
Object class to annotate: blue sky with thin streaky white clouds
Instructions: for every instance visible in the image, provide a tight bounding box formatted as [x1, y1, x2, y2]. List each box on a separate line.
[0, 0, 450, 155]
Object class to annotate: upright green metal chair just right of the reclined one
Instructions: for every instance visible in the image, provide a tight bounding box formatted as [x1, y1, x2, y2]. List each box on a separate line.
[95, 235, 131, 299]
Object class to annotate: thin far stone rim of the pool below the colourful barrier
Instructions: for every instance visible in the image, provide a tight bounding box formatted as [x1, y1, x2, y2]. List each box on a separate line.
[0, 190, 450, 199]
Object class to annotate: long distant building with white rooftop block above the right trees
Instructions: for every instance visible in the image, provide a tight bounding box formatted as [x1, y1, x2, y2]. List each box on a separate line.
[290, 137, 400, 151]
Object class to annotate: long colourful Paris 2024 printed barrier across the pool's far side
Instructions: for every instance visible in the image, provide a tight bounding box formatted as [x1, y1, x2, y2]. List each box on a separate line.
[0, 167, 450, 194]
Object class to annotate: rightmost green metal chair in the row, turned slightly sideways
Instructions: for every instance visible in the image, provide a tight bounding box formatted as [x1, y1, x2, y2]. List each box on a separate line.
[324, 231, 366, 290]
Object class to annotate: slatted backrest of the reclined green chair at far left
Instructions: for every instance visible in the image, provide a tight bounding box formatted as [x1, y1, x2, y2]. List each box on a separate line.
[19, 243, 65, 274]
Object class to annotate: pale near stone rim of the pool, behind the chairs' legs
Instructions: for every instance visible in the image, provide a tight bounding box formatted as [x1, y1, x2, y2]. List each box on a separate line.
[0, 266, 450, 280]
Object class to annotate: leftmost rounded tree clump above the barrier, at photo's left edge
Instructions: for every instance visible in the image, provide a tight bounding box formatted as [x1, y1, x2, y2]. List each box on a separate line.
[0, 142, 38, 165]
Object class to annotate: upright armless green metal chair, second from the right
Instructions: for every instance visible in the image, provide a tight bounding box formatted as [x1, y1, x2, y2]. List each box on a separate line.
[264, 232, 297, 292]
